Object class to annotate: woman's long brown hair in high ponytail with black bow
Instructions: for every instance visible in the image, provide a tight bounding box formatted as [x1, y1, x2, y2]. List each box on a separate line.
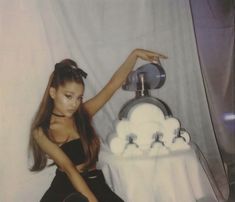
[29, 59, 100, 171]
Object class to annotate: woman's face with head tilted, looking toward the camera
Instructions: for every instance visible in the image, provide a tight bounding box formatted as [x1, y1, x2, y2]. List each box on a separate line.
[50, 82, 84, 117]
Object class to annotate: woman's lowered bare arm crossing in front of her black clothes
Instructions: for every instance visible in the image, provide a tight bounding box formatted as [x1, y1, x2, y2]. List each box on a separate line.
[33, 128, 98, 202]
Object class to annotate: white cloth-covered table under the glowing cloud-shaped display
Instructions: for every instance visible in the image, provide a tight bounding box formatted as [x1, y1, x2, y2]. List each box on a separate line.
[99, 149, 218, 202]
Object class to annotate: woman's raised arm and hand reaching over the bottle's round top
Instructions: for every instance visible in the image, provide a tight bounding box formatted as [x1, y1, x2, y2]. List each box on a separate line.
[84, 49, 167, 116]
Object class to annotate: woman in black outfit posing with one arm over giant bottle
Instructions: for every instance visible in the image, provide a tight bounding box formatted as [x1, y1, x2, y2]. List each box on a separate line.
[30, 49, 166, 202]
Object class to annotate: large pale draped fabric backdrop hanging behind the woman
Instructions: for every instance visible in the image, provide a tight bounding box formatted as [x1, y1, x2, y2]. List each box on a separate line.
[0, 0, 228, 202]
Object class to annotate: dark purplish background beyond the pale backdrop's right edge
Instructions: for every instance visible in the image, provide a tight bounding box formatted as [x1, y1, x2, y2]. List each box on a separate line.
[191, 0, 235, 159]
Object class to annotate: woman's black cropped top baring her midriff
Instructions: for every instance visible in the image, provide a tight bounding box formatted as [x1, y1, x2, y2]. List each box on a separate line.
[60, 138, 86, 165]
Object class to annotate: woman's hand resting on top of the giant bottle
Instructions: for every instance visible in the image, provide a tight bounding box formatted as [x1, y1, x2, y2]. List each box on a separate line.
[132, 49, 167, 62]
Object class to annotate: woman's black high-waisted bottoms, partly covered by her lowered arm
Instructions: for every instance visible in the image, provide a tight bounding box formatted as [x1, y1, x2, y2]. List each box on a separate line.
[40, 169, 124, 202]
